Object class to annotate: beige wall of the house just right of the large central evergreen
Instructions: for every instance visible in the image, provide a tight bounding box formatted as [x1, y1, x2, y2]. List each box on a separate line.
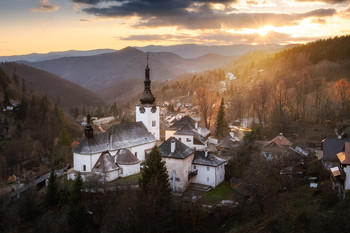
[163, 154, 194, 192]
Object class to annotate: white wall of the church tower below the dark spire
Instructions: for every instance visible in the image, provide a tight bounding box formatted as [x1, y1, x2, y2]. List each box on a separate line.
[136, 106, 160, 140]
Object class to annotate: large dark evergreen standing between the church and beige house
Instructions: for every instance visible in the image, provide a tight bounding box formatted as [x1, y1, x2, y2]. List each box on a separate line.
[139, 145, 170, 199]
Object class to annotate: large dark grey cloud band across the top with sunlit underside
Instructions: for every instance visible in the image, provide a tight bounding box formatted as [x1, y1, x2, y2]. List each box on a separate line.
[73, 0, 336, 29]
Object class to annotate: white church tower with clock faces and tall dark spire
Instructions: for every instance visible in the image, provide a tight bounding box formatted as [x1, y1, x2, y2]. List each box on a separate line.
[136, 53, 160, 140]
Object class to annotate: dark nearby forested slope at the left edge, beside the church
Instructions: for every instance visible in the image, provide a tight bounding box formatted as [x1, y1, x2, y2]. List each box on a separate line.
[0, 67, 81, 183]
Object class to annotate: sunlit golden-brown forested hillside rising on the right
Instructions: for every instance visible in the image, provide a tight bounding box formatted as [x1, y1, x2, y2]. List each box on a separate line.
[150, 36, 350, 139]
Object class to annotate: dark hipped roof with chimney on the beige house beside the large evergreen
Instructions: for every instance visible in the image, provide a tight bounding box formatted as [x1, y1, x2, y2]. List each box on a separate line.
[159, 137, 194, 159]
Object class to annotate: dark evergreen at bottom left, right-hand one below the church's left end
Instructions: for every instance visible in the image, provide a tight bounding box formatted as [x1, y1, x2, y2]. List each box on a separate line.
[67, 173, 87, 232]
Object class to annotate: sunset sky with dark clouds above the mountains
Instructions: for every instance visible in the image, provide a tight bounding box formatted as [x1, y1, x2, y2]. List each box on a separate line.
[0, 0, 350, 56]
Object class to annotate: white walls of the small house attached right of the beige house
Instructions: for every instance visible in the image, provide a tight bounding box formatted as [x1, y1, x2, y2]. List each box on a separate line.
[191, 164, 225, 188]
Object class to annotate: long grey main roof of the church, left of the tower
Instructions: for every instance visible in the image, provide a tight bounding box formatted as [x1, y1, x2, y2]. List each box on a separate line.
[73, 122, 156, 154]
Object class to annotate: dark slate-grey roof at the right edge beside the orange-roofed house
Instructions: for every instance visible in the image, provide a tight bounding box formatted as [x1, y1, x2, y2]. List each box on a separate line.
[322, 138, 350, 161]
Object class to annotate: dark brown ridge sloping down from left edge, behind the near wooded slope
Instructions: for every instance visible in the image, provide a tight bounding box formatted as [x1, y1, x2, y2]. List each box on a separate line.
[0, 62, 105, 108]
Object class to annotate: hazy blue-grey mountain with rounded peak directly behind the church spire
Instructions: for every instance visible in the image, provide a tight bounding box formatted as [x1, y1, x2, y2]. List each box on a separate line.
[23, 47, 234, 92]
